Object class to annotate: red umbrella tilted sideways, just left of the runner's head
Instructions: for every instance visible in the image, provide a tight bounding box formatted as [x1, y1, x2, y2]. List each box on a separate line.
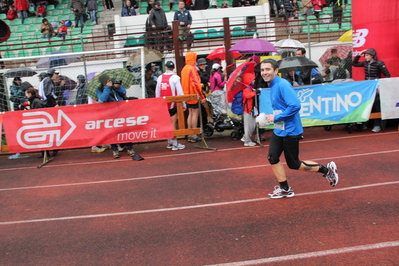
[226, 62, 255, 103]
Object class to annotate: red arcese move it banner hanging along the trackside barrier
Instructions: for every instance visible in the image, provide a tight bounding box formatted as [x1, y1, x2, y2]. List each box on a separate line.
[4, 98, 173, 152]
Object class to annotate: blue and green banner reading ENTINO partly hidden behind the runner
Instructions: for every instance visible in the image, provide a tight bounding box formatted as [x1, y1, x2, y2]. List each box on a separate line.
[259, 80, 379, 127]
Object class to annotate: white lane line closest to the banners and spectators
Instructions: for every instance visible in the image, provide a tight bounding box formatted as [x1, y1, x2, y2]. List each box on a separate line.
[0, 131, 399, 172]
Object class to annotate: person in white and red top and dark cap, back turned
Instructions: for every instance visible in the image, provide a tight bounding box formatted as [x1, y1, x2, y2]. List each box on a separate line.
[155, 61, 186, 151]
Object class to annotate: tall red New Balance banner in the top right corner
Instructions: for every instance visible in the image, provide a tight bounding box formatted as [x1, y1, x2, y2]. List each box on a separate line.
[352, 0, 399, 80]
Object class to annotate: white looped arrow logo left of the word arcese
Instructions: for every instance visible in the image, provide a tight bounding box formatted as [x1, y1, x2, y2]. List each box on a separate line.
[17, 110, 76, 149]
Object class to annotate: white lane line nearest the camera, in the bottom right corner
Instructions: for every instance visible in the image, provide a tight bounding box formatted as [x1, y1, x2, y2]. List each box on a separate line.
[205, 241, 399, 266]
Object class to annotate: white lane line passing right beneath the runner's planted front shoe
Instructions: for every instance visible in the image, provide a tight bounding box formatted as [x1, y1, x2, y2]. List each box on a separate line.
[0, 181, 399, 226]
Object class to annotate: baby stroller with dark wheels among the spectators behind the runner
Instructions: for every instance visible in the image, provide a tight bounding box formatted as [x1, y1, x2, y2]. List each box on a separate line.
[204, 90, 244, 140]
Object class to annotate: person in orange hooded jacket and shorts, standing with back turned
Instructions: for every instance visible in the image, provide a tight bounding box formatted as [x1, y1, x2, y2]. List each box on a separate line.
[180, 52, 206, 142]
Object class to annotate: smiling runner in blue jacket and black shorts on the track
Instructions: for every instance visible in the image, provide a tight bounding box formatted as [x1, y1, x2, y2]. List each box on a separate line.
[260, 59, 338, 199]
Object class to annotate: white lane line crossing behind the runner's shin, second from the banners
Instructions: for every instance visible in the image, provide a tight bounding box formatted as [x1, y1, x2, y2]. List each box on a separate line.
[0, 150, 399, 192]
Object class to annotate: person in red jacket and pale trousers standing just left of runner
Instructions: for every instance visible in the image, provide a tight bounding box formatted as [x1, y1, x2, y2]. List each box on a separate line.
[241, 86, 256, 146]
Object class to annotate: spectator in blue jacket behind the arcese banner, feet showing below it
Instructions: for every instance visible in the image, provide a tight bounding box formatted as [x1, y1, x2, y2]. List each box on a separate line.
[96, 74, 139, 159]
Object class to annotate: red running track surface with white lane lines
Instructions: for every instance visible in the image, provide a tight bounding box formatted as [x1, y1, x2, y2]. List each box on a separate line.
[0, 126, 399, 265]
